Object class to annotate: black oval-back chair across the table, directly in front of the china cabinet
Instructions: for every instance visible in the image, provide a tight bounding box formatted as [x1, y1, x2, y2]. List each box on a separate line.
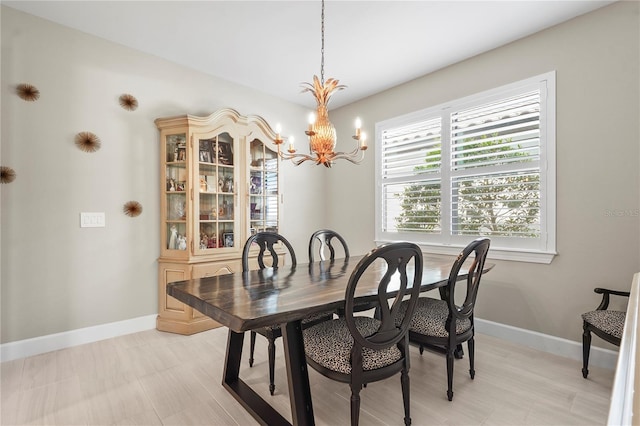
[242, 232, 333, 395]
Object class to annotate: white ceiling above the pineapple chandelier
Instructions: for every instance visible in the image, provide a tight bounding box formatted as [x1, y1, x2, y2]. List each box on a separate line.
[2, 0, 613, 108]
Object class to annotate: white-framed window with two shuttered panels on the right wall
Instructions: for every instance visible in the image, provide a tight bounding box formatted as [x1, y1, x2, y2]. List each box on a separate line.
[376, 72, 555, 263]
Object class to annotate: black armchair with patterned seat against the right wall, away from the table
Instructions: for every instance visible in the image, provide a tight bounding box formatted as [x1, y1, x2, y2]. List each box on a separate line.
[582, 287, 629, 379]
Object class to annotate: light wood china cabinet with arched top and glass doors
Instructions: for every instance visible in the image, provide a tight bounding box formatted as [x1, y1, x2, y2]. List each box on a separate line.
[155, 108, 280, 334]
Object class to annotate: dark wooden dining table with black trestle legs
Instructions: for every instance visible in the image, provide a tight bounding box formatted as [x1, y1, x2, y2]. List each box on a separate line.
[167, 251, 493, 425]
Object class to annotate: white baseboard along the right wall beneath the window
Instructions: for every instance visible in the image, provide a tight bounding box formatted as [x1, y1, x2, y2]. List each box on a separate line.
[474, 318, 618, 370]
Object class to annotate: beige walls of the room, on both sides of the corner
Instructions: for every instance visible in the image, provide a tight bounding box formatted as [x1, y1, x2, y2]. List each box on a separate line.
[0, 2, 640, 344]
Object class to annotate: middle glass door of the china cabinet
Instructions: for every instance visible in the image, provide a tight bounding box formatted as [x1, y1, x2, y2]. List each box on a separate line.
[194, 133, 236, 253]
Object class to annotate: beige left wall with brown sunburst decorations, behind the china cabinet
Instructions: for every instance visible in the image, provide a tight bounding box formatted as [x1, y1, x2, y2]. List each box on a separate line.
[0, 6, 324, 343]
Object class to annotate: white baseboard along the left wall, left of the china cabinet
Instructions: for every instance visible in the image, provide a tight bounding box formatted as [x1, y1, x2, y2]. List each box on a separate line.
[0, 314, 158, 362]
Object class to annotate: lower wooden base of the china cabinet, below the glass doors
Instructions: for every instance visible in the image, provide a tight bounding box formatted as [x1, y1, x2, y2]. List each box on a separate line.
[156, 259, 242, 335]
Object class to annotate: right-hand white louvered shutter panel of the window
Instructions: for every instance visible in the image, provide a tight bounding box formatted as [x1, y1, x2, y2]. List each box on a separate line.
[450, 90, 540, 238]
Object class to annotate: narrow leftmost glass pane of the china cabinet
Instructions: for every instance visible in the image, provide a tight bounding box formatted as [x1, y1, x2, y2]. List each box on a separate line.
[163, 133, 187, 251]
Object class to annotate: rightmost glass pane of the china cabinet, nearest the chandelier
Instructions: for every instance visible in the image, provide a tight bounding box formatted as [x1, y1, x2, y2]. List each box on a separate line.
[248, 139, 278, 235]
